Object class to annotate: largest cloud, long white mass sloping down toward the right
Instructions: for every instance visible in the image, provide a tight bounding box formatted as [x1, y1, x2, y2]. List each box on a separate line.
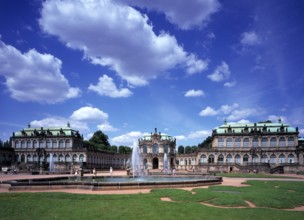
[39, 0, 211, 86]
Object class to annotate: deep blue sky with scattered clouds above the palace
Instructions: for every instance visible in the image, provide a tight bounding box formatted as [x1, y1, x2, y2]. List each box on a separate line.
[0, 0, 304, 146]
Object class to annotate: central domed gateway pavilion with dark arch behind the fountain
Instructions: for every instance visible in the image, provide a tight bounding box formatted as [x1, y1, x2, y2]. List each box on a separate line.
[138, 128, 176, 169]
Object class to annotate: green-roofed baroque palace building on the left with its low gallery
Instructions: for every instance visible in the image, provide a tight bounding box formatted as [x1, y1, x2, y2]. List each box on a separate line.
[11, 123, 129, 172]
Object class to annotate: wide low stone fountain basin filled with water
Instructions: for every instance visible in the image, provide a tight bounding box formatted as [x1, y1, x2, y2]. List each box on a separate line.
[2, 175, 222, 191]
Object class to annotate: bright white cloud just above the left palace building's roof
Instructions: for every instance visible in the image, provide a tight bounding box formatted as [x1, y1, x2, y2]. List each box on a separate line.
[71, 106, 109, 121]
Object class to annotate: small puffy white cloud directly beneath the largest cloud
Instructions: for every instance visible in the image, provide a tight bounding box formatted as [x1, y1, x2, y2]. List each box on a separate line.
[89, 75, 132, 98]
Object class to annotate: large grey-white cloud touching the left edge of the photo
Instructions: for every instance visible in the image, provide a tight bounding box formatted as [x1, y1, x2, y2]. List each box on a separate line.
[0, 40, 80, 104]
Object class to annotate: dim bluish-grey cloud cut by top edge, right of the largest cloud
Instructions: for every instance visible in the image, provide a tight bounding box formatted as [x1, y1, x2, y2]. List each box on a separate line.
[121, 0, 221, 30]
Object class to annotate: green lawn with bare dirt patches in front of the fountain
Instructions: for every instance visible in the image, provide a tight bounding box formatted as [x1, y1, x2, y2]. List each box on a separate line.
[0, 180, 304, 220]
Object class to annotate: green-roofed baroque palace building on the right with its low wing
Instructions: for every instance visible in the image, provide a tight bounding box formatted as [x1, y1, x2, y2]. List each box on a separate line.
[177, 119, 304, 172]
